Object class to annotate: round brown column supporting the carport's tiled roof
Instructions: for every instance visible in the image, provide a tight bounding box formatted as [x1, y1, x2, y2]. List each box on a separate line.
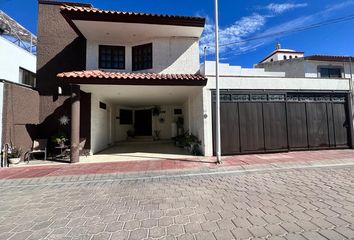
[70, 85, 80, 163]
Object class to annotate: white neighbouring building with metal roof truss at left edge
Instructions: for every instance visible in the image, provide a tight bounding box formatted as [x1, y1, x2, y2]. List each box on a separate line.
[0, 11, 36, 149]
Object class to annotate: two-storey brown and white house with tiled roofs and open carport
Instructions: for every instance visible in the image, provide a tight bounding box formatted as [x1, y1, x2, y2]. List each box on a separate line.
[37, 1, 206, 161]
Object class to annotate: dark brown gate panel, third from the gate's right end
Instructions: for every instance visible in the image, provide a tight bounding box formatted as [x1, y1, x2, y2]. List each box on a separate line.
[288, 103, 309, 149]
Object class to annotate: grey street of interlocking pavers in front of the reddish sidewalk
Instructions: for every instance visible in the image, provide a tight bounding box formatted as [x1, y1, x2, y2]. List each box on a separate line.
[0, 167, 354, 240]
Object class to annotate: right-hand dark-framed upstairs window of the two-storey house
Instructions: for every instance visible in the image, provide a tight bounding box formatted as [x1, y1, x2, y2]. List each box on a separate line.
[132, 43, 152, 71]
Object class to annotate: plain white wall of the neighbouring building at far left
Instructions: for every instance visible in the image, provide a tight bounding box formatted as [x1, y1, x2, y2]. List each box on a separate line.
[0, 37, 36, 83]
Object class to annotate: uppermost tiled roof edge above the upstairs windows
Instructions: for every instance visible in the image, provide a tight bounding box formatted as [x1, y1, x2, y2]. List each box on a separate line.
[61, 4, 205, 27]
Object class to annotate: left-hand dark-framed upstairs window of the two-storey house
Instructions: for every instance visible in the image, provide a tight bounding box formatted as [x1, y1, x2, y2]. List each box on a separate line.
[98, 45, 126, 70]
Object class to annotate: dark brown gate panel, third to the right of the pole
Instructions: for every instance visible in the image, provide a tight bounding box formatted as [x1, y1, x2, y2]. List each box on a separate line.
[263, 103, 288, 150]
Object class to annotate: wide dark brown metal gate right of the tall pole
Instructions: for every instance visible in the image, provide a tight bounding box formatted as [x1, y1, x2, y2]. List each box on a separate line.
[212, 91, 351, 155]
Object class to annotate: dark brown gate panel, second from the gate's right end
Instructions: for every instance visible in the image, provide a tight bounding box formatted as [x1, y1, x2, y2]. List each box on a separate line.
[306, 103, 330, 148]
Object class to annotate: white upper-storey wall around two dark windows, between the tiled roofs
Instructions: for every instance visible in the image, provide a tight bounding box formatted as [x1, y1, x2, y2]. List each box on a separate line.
[86, 37, 199, 74]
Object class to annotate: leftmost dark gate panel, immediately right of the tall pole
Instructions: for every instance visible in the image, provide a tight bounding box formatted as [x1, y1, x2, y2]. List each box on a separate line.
[220, 102, 240, 155]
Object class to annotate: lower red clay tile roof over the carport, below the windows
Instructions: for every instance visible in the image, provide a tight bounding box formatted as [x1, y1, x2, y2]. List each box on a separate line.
[57, 70, 207, 86]
